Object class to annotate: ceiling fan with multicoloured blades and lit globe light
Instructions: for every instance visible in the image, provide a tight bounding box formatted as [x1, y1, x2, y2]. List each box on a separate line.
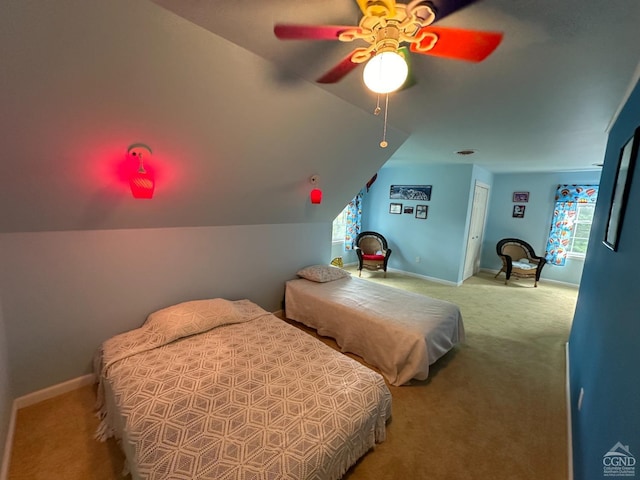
[274, 0, 502, 93]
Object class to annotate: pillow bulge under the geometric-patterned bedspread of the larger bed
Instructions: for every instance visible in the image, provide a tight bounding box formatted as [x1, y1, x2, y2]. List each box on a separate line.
[144, 298, 244, 342]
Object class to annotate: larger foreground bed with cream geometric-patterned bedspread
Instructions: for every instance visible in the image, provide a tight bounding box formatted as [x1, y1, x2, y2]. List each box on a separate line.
[94, 299, 391, 480]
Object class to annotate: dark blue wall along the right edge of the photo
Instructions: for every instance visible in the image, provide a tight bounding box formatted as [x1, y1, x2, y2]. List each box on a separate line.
[569, 78, 640, 480]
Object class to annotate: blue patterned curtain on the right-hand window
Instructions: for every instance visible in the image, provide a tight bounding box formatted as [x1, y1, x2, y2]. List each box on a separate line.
[546, 185, 598, 266]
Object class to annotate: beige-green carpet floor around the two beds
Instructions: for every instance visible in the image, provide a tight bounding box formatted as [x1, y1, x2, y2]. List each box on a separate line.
[9, 267, 577, 480]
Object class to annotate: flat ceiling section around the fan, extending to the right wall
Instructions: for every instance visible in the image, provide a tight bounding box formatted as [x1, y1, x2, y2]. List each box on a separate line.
[154, 0, 640, 172]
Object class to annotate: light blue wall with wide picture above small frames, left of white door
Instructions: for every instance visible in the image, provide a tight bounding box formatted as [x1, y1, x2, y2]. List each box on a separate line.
[362, 163, 484, 284]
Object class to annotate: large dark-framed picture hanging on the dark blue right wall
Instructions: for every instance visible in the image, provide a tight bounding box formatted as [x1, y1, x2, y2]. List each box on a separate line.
[603, 127, 640, 252]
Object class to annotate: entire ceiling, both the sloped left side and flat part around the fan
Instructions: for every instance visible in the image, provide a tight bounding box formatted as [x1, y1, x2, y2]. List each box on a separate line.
[0, 0, 640, 232]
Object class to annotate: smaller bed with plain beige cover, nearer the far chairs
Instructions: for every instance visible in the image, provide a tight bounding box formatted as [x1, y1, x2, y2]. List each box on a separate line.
[285, 265, 465, 386]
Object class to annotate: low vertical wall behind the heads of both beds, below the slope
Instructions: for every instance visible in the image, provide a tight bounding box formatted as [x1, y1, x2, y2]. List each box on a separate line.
[0, 223, 331, 396]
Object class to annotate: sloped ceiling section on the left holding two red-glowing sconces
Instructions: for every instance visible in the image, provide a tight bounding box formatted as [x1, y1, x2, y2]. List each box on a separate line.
[0, 0, 407, 232]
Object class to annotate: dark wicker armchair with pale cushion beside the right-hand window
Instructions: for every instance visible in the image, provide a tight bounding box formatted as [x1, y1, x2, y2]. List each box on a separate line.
[496, 238, 547, 287]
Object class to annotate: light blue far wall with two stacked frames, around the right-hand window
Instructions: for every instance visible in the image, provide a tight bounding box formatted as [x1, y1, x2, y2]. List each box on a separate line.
[480, 170, 600, 285]
